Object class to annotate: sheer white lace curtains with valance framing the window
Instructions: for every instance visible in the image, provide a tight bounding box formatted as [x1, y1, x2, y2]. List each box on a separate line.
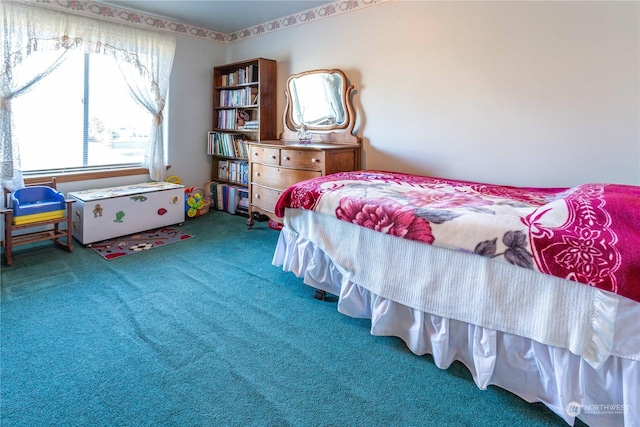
[0, 1, 176, 189]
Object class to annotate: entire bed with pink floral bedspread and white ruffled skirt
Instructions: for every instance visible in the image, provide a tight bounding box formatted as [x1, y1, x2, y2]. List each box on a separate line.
[273, 171, 640, 426]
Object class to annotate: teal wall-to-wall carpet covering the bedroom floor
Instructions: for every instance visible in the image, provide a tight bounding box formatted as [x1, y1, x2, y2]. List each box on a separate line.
[0, 211, 580, 427]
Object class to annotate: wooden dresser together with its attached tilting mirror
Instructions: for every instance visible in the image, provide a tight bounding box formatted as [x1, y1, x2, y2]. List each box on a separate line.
[247, 69, 362, 228]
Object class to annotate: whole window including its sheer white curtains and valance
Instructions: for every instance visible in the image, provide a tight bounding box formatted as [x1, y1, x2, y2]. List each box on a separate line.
[0, 1, 176, 188]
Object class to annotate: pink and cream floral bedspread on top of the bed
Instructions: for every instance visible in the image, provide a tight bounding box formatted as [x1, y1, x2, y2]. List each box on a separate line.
[276, 171, 640, 302]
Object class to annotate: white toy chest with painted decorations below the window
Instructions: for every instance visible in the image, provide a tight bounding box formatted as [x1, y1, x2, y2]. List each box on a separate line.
[67, 182, 185, 245]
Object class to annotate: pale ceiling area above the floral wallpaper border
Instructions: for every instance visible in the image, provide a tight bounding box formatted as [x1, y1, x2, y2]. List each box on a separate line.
[96, 0, 332, 34]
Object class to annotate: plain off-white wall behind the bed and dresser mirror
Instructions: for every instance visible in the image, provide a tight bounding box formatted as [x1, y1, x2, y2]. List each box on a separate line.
[222, 1, 640, 186]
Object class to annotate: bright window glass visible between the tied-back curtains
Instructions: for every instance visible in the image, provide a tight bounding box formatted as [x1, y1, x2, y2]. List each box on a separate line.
[12, 51, 152, 175]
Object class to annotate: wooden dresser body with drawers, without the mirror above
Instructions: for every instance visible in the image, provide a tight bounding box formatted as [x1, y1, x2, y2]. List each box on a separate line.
[247, 140, 360, 227]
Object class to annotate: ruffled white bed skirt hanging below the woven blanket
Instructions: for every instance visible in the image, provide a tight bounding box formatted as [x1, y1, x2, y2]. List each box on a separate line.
[273, 225, 640, 427]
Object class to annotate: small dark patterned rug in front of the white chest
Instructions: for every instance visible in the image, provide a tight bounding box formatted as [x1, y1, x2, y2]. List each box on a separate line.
[91, 227, 193, 259]
